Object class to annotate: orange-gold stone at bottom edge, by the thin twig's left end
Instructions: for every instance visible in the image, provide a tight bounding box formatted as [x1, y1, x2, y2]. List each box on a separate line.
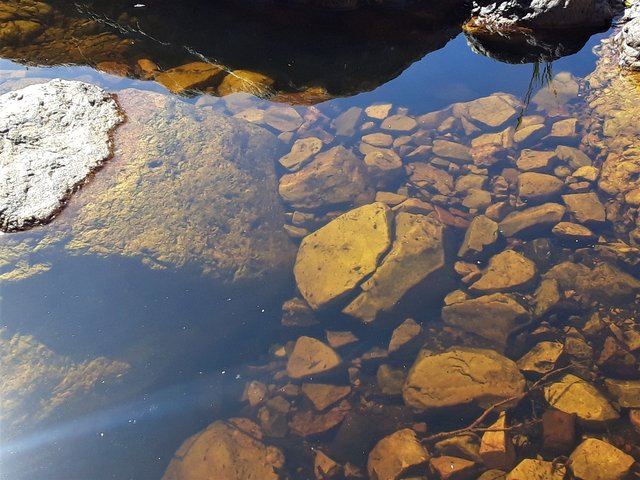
[367, 428, 429, 480]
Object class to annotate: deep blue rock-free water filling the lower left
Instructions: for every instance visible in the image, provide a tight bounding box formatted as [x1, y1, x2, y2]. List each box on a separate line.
[0, 256, 290, 480]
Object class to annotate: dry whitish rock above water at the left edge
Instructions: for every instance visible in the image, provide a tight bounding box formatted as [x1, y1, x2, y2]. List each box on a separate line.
[0, 79, 123, 232]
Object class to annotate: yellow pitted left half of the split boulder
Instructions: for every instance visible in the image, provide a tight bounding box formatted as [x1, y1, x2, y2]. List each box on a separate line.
[294, 203, 392, 309]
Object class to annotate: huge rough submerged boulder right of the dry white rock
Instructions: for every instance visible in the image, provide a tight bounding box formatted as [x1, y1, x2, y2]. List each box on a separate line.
[65, 90, 294, 282]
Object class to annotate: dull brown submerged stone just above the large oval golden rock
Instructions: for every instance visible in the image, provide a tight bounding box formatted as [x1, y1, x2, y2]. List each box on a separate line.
[442, 293, 530, 349]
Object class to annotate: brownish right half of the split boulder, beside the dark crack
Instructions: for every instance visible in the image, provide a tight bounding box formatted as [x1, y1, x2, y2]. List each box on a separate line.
[343, 212, 445, 322]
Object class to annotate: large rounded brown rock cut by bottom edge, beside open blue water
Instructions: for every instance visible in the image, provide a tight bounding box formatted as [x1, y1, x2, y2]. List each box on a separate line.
[162, 418, 284, 480]
